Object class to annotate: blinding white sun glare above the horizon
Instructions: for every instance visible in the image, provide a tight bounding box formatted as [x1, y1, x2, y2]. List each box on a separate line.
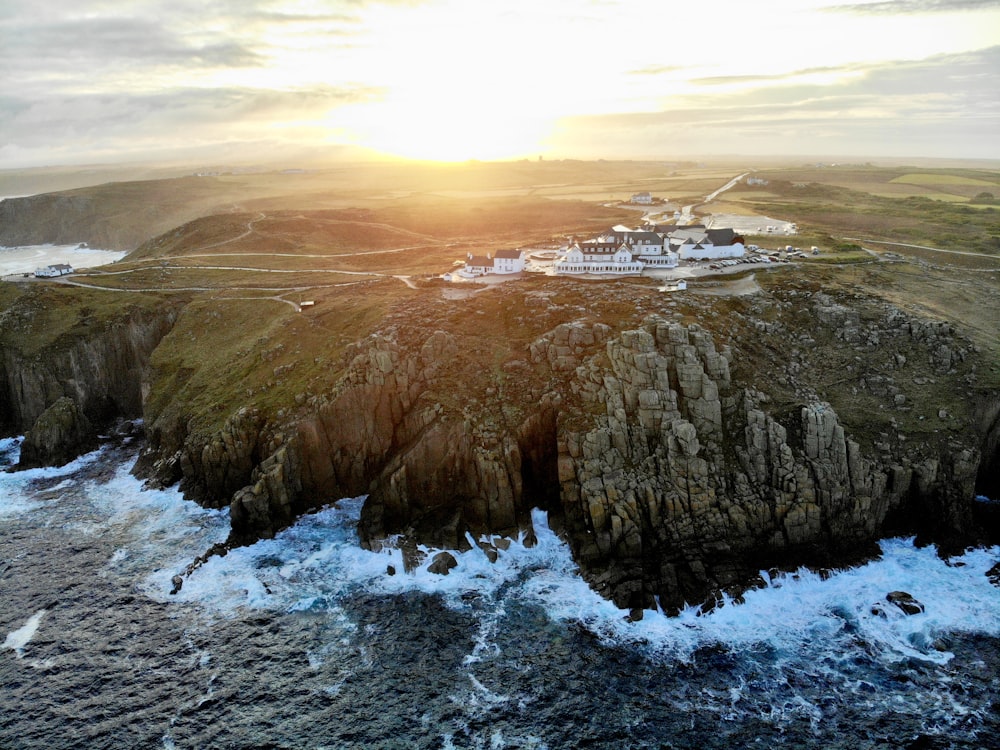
[330, 0, 572, 162]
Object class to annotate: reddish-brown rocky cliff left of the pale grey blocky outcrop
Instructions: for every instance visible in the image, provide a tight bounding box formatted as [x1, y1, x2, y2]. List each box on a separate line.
[210, 331, 554, 548]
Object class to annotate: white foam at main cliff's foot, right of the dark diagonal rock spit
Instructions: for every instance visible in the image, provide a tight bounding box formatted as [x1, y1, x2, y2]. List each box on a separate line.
[154, 498, 1000, 665]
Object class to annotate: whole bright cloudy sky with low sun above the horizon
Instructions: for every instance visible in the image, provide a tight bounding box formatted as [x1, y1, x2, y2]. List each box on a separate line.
[0, 0, 1000, 169]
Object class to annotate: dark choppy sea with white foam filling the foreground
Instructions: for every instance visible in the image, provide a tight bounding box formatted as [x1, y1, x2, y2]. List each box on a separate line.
[0, 440, 1000, 749]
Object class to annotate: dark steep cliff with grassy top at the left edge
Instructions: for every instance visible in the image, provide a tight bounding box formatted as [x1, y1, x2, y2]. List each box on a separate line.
[0, 289, 179, 468]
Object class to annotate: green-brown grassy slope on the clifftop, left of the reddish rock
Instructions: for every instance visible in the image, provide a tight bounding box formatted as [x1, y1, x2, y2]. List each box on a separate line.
[146, 282, 407, 435]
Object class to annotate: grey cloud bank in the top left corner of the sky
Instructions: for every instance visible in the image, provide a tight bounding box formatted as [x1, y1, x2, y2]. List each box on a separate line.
[0, 0, 372, 88]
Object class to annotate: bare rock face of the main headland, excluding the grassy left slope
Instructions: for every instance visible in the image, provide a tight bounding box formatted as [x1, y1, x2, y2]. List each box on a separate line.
[129, 284, 983, 610]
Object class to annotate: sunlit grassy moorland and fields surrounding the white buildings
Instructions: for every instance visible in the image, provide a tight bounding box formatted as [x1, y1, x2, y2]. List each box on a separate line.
[0, 162, 1000, 438]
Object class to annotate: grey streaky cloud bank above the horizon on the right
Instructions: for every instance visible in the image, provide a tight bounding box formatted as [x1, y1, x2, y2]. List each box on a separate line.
[553, 47, 1000, 158]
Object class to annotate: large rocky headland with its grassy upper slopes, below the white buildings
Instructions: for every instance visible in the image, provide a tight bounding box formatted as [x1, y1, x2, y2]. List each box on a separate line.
[4, 280, 997, 610]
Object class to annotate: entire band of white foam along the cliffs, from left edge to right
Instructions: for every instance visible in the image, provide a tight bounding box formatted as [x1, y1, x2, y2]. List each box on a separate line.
[9, 440, 1000, 668]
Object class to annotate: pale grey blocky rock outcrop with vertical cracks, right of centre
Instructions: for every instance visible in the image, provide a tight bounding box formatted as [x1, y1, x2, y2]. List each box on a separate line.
[559, 319, 978, 609]
